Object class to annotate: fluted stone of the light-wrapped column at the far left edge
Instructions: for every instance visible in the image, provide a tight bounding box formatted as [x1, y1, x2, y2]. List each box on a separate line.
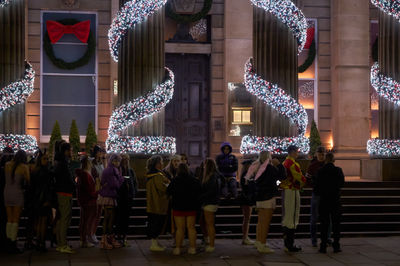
[0, 0, 25, 134]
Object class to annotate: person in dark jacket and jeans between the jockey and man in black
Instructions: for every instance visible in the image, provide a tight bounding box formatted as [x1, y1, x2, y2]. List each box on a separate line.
[306, 146, 325, 247]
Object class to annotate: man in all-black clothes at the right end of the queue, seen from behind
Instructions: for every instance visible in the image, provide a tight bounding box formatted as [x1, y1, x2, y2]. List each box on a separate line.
[315, 153, 344, 253]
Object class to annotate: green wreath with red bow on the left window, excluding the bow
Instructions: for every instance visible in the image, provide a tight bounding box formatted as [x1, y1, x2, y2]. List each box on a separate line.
[43, 19, 96, 70]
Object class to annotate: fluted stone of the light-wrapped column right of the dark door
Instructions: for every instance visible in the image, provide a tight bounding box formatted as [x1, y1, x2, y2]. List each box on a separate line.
[253, 7, 298, 137]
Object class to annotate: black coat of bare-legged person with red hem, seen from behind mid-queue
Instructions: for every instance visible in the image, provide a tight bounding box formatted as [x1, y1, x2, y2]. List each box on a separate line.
[167, 174, 201, 211]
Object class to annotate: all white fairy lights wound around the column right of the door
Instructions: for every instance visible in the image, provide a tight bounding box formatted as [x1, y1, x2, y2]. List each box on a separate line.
[240, 0, 310, 154]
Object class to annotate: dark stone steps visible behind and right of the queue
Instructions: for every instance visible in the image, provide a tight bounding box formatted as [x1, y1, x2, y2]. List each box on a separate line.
[21, 182, 400, 239]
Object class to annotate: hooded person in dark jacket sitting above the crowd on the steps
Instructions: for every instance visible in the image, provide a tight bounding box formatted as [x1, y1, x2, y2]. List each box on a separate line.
[215, 142, 238, 199]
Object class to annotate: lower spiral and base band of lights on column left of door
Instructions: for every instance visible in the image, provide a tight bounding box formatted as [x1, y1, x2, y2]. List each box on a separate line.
[106, 68, 176, 154]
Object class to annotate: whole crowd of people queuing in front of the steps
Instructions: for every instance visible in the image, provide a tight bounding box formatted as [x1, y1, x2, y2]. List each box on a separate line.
[0, 141, 344, 255]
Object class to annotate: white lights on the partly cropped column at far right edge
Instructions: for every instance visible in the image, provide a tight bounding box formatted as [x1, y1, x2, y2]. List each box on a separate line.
[367, 0, 400, 157]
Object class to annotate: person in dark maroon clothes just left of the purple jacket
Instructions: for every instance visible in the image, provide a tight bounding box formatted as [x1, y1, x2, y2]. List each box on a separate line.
[75, 155, 97, 248]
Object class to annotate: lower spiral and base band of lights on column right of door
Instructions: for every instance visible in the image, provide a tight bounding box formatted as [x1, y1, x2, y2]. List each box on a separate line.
[240, 59, 310, 154]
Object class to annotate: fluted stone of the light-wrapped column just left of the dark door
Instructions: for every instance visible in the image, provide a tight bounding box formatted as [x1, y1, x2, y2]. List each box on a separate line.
[118, 0, 165, 136]
